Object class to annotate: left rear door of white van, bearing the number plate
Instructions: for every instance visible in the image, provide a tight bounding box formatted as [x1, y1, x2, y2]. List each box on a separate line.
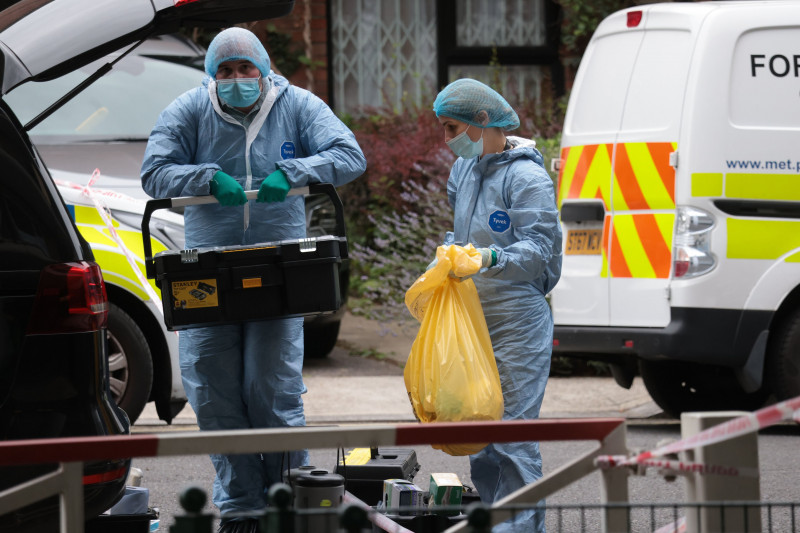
[551, 8, 643, 326]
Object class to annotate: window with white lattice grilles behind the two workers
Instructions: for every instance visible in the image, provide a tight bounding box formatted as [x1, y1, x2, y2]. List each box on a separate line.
[330, 0, 563, 114]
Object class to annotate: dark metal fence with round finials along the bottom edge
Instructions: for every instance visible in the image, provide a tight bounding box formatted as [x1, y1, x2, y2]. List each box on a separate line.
[164, 484, 800, 533]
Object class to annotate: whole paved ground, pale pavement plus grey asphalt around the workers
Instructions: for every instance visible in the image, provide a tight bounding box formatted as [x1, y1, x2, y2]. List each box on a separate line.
[128, 317, 800, 532]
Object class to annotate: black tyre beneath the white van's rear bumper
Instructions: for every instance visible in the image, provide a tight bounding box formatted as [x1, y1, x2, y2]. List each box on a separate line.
[639, 360, 767, 418]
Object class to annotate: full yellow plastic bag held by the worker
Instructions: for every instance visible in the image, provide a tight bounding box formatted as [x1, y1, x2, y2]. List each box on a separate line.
[403, 244, 503, 455]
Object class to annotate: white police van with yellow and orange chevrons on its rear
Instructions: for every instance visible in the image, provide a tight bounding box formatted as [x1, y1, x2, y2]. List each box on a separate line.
[551, 1, 800, 415]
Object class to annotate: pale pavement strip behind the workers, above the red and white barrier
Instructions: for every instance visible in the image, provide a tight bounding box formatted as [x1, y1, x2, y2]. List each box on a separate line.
[137, 314, 664, 426]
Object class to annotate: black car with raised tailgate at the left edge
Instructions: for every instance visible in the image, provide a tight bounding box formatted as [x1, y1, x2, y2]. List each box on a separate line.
[0, 0, 294, 532]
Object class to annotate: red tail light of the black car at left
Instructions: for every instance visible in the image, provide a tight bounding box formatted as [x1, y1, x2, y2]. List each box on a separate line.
[28, 261, 109, 334]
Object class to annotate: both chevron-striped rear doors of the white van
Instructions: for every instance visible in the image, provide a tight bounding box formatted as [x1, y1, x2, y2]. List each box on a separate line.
[552, 6, 694, 327]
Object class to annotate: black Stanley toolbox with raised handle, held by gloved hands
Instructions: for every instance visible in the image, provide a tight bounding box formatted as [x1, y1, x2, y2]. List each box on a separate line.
[142, 183, 348, 331]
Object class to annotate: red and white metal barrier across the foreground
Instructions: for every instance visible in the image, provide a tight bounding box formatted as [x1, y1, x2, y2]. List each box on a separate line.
[0, 418, 628, 533]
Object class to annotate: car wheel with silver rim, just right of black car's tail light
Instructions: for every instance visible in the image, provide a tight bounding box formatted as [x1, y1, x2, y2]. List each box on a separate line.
[107, 303, 153, 425]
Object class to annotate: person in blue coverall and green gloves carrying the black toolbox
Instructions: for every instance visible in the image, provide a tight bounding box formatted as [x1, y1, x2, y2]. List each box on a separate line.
[141, 28, 366, 532]
